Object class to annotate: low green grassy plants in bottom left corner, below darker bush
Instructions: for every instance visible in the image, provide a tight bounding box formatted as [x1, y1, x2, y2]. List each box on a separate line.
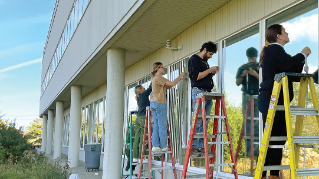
[0, 151, 69, 179]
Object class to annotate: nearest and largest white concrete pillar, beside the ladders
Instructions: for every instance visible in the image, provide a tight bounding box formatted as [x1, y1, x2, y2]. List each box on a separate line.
[102, 48, 125, 179]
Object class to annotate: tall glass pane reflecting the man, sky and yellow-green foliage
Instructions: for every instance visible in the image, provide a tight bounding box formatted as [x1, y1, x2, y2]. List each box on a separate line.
[224, 24, 259, 176]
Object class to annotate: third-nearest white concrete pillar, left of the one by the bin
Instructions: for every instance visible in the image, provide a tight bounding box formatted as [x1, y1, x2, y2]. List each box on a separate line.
[53, 101, 63, 159]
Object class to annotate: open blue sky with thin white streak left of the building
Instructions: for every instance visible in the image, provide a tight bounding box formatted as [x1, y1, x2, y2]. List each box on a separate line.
[0, 0, 55, 129]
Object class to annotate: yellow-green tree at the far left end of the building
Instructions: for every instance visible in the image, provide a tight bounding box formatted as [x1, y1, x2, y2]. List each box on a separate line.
[26, 118, 43, 145]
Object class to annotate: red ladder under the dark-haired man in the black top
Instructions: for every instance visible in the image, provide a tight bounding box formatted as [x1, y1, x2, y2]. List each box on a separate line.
[181, 92, 238, 179]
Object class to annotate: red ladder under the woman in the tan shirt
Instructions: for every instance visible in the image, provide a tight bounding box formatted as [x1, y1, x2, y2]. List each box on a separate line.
[138, 106, 177, 179]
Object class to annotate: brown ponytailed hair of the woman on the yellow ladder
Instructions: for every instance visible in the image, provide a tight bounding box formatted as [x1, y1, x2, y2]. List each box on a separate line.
[258, 24, 282, 68]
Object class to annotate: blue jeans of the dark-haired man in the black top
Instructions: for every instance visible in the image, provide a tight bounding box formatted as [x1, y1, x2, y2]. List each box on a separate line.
[192, 88, 213, 148]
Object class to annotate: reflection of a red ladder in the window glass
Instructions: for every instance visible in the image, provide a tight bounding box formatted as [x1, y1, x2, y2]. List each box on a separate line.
[235, 96, 259, 176]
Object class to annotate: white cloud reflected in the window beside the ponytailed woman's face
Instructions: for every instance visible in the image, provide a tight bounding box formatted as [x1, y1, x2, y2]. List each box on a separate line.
[282, 14, 318, 42]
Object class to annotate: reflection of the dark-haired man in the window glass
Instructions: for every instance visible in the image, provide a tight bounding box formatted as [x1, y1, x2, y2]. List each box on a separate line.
[236, 47, 259, 155]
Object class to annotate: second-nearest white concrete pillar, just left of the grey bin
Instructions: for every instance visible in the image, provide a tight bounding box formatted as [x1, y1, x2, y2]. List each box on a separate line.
[68, 86, 82, 168]
